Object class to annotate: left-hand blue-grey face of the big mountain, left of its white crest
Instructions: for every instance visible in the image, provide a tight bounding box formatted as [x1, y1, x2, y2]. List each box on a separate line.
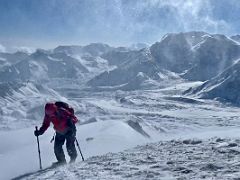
[150, 32, 206, 73]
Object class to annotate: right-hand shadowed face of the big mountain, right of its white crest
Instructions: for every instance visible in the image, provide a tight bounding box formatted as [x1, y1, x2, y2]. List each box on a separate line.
[183, 35, 240, 81]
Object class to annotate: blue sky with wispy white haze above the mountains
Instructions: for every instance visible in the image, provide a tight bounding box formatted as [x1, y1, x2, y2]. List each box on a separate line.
[0, 0, 240, 48]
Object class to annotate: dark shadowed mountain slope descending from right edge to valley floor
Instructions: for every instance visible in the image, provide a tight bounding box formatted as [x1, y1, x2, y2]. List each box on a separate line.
[186, 61, 240, 105]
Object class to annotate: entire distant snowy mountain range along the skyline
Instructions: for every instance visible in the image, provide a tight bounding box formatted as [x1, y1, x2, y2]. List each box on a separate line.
[0, 32, 240, 89]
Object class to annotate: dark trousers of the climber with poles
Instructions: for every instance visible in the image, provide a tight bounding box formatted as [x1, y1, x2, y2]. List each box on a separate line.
[54, 131, 77, 163]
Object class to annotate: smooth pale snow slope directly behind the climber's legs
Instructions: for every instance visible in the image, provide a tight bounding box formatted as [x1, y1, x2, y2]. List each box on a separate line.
[0, 121, 152, 179]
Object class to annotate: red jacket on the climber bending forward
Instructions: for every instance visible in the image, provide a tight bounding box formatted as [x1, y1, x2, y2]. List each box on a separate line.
[40, 108, 78, 133]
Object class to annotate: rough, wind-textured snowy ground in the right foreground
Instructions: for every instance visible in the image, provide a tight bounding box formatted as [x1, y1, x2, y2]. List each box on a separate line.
[13, 138, 240, 180]
